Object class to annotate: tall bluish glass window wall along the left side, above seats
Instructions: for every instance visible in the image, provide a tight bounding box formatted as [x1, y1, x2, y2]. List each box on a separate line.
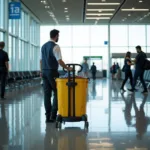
[0, 0, 40, 71]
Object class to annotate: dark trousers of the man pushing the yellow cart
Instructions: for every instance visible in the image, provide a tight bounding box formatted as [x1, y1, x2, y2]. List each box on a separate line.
[42, 70, 59, 119]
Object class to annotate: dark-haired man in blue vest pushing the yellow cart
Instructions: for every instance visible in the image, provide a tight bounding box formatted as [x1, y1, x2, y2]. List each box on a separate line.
[40, 29, 72, 122]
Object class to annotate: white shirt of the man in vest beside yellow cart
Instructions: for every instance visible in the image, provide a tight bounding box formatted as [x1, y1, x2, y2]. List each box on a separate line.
[41, 40, 62, 61]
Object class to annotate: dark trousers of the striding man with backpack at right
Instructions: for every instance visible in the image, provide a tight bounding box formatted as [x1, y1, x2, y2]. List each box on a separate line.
[132, 69, 147, 91]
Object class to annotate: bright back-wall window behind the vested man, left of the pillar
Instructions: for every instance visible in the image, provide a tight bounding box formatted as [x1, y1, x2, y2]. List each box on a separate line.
[41, 25, 108, 68]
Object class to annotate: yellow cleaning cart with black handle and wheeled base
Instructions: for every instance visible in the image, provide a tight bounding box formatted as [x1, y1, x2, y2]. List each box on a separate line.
[56, 64, 89, 128]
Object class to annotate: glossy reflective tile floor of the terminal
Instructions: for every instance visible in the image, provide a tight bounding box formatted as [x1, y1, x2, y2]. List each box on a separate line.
[0, 80, 150, 150]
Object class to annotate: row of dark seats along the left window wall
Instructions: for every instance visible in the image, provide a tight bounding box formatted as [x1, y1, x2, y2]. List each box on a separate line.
[7, 71, 40, 88]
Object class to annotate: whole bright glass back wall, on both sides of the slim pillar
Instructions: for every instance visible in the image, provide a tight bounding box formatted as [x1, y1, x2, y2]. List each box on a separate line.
[41, 25, 150, 72]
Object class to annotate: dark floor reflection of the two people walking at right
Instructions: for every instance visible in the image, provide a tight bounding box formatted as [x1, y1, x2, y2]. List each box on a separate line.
[122, 94, 150, 140]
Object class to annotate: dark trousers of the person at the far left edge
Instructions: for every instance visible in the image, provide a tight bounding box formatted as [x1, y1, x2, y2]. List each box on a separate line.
[0, 70, 7, 98]
